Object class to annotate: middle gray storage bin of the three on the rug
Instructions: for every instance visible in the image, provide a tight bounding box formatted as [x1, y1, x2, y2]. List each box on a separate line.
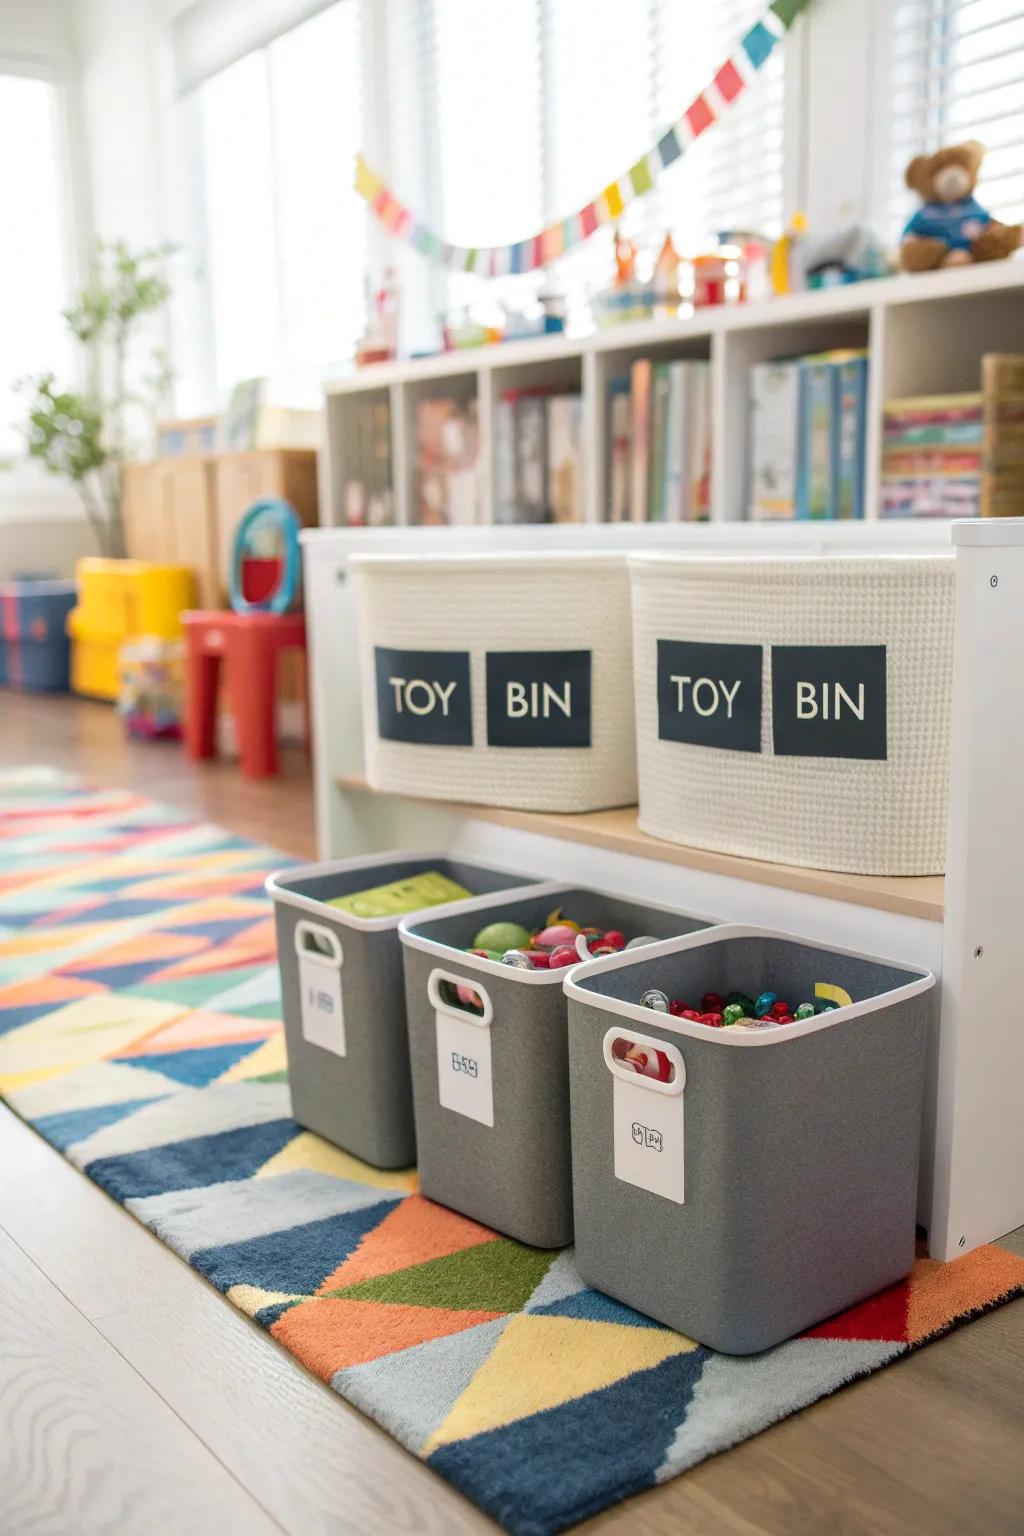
[401, 885, 718, 1247]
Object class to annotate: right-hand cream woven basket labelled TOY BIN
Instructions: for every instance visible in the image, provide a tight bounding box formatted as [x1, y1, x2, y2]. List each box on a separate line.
[629, 553, 953, 876]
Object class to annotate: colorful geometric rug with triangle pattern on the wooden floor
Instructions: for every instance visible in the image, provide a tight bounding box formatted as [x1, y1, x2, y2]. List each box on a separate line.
[0, 770, 1024, 1536]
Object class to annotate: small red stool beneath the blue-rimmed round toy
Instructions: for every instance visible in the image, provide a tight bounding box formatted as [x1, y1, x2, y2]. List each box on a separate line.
[181, 610, 309, 779]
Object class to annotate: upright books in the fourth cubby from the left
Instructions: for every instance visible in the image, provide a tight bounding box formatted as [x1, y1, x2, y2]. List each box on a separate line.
[608, 358, 711, 522]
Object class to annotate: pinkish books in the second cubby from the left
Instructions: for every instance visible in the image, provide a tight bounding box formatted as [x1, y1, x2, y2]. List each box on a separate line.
[413, 398, 481, 528]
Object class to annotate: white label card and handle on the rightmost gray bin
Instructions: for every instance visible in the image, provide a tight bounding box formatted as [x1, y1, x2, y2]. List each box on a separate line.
[605, 1029, 686, 1206]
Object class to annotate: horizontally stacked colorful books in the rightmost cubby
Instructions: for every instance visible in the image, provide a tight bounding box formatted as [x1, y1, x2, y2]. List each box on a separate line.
[881, 392, 983, 518]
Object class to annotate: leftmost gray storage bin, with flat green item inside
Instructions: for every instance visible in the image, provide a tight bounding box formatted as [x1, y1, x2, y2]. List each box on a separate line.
[266, 851, 534, 1167]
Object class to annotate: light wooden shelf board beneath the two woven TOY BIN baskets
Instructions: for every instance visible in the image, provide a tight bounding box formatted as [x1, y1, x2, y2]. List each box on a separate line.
[336, 774, 946, 923]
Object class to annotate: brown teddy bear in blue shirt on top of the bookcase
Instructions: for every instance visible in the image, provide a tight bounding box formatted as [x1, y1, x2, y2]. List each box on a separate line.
[900, 138, 1021, 272]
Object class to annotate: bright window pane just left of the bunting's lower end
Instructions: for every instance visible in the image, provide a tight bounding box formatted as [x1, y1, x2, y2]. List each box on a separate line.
[193, 0, 367, 404]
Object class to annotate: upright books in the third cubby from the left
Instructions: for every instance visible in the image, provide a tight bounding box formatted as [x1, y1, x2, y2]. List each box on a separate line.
[494, 389, 583, 524]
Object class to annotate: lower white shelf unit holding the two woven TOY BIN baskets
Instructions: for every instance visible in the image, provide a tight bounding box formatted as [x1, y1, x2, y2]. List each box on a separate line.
[302, 518, 1024, 1260]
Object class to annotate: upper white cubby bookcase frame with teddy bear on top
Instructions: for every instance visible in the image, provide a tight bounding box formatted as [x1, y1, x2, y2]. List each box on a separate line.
[321, 258, 1024, 527]
